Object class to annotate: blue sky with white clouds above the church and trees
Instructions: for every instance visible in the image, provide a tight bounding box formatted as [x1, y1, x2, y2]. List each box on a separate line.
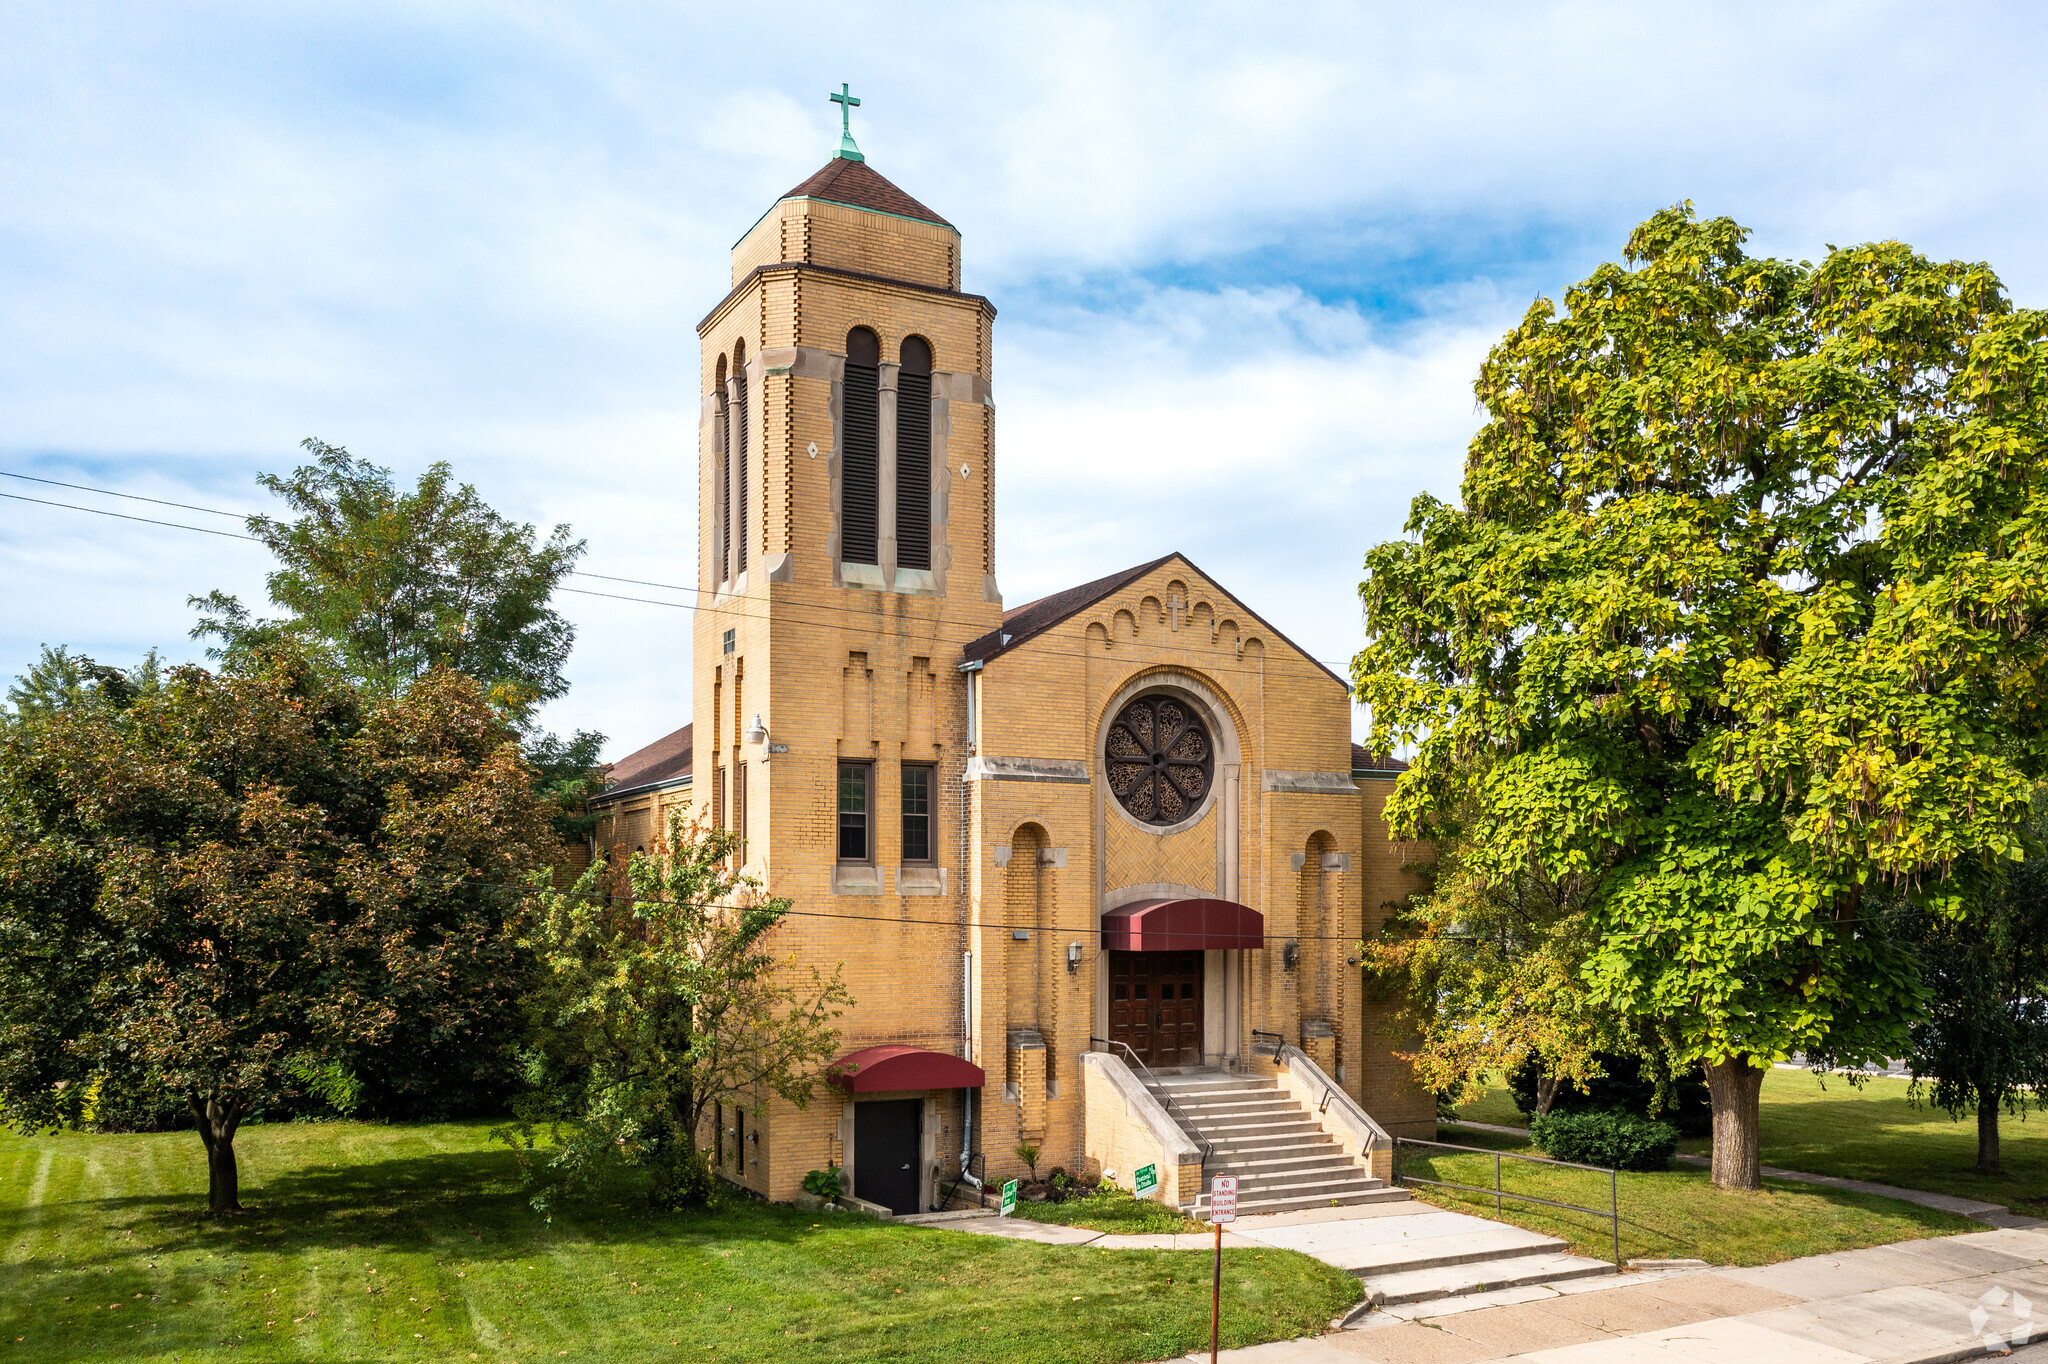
[0, 0, 2048, 754]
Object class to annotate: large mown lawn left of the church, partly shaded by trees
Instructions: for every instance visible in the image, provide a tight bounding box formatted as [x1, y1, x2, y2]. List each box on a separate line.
[0, 1122, 1358, 1360]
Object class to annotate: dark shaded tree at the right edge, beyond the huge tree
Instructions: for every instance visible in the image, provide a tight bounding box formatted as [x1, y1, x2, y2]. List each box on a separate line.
[1901, 795, 2048, 1174]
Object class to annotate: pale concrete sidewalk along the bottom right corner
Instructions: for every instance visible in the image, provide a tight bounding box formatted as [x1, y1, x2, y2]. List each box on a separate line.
[1155, 1229, 2048, 1364]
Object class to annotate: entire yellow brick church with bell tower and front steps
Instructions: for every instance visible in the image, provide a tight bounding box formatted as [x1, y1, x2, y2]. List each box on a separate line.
[596, 96, 1436, 1214]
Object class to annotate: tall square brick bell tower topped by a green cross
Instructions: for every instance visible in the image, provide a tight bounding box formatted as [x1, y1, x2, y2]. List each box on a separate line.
[692, 88, 1001, 1073]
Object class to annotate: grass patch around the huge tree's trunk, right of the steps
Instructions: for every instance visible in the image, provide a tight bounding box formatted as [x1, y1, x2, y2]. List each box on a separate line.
[1403, 1126, 1982, 1264]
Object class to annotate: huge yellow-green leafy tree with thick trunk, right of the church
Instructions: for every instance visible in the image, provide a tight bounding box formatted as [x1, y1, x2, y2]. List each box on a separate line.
[1352, 205, 2048, 1188]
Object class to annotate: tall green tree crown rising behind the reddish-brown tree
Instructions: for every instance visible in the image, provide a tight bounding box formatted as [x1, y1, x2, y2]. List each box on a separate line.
[193, 440, 584, 719]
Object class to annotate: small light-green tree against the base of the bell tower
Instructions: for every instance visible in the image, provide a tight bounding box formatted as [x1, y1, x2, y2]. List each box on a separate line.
[502, 817, 852, 1208]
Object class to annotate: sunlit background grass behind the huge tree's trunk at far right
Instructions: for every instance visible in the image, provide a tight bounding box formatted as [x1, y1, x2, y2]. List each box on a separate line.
[1446, 1069, 2048, 1217]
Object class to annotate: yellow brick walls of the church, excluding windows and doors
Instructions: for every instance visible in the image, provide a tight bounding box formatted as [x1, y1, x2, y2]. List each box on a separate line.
[655, 151, 1434, 1202]
